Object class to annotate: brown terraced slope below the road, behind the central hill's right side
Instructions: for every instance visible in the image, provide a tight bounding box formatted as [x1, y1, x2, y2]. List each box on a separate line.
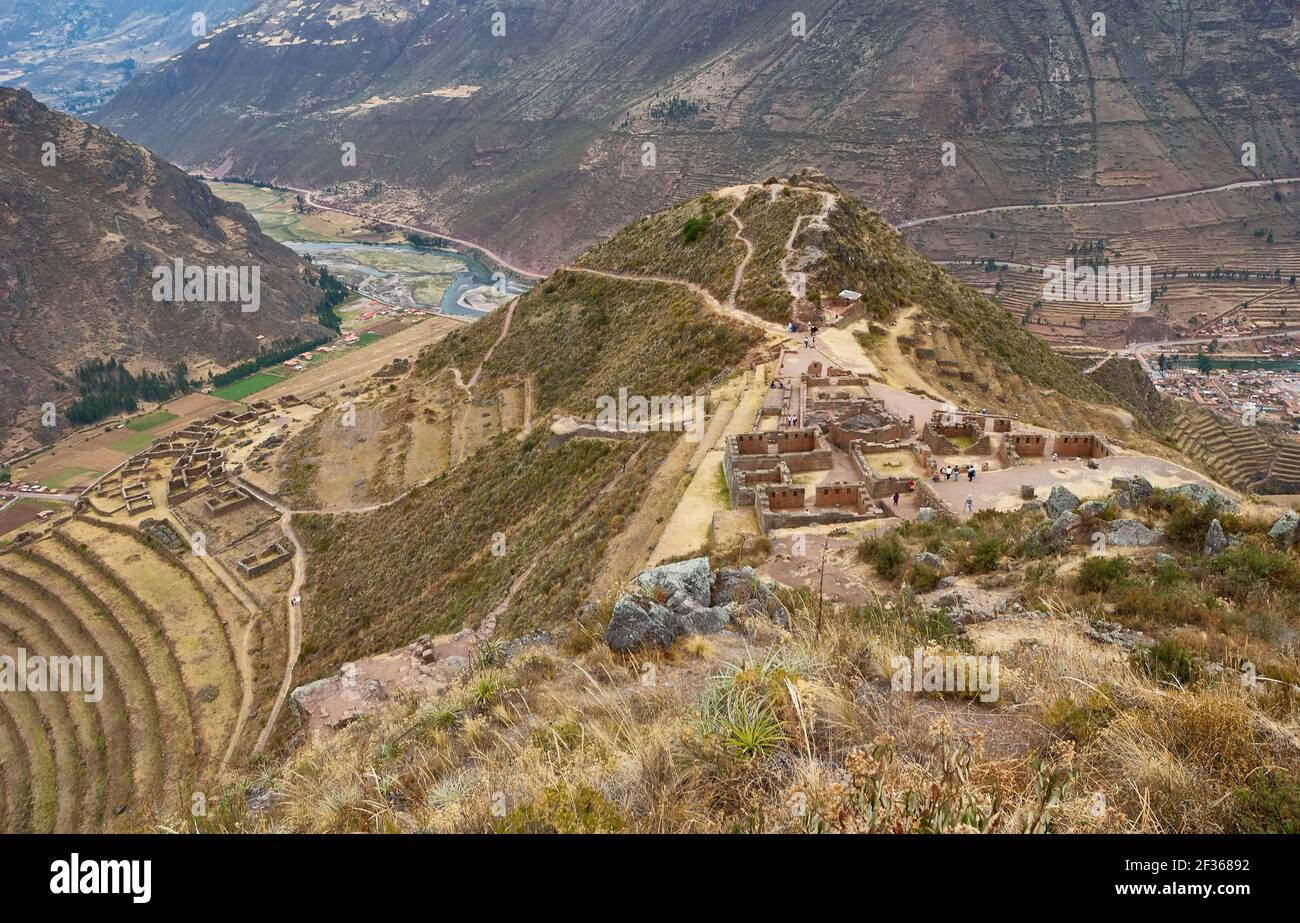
[905, 183, 1300, 346]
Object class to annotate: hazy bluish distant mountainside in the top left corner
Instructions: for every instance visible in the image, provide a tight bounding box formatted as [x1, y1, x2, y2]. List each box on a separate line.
[0, 0, 246, 114]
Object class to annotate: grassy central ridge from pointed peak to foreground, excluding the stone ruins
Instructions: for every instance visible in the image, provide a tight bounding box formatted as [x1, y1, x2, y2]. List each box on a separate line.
[177, 185, 1300, 833]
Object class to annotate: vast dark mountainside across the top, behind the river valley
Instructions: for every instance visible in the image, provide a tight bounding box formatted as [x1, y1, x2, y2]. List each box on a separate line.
[99, 0, 1300, 268]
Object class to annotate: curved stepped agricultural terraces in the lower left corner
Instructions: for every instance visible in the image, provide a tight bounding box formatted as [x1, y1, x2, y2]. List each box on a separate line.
[0, 517, 283, 832]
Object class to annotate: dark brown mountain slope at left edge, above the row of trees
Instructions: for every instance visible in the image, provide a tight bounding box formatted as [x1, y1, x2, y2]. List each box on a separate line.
[0, 88, 325, 454]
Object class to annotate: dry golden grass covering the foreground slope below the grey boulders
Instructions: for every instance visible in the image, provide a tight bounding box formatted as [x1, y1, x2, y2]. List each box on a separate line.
[172, 566, 1297, 833]
